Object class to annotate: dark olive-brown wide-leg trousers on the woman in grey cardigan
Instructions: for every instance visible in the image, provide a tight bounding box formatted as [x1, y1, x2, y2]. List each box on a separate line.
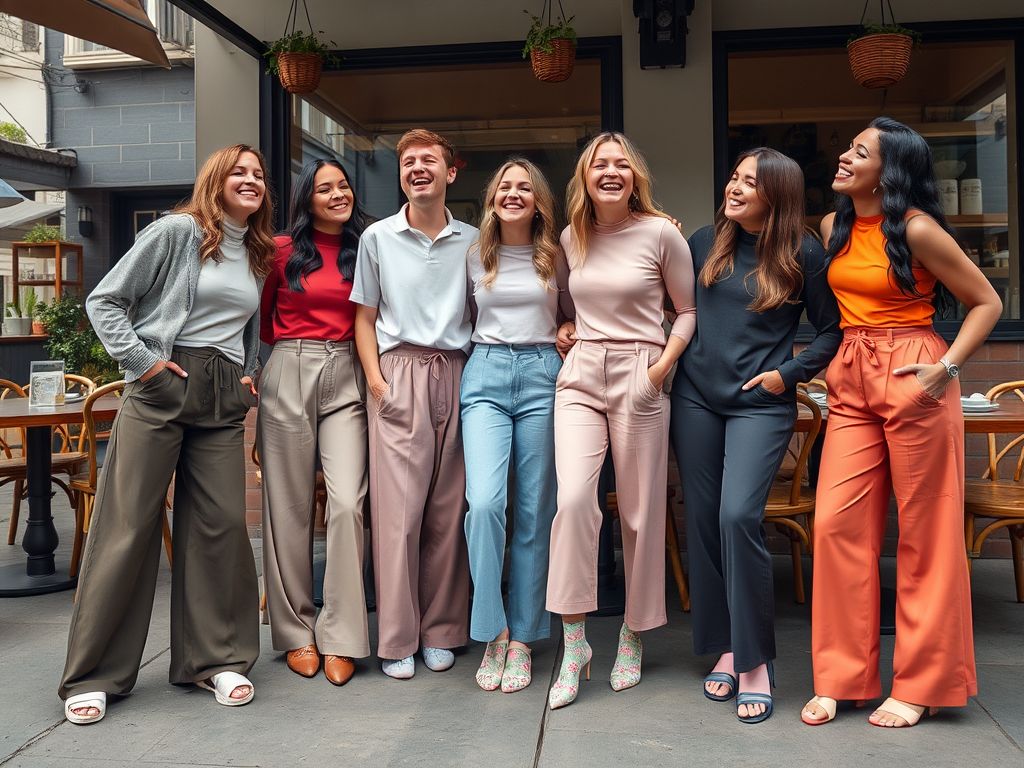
[58, 347, 259, 698]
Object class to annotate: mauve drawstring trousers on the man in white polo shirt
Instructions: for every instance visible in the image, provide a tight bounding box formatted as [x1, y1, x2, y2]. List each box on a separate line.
[369, 344, 469, 658]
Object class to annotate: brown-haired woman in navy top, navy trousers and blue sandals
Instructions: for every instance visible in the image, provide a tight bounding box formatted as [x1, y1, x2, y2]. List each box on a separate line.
[672, 147, 841, 723]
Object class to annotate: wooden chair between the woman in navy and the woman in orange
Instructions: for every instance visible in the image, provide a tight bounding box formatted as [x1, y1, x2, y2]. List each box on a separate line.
[765, 390, 821, 604]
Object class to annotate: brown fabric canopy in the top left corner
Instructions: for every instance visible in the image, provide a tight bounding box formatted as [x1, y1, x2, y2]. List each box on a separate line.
[0, 0, 171, 70]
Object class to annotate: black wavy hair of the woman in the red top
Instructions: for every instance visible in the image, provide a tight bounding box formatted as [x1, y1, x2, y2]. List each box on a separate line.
[285, 160, 370, 293]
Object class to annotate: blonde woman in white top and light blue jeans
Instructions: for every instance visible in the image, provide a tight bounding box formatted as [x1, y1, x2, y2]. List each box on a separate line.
[461, 158, 571, 693]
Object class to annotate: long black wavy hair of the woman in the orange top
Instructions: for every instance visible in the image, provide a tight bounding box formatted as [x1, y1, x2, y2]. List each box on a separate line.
[825, 117, 956, 316]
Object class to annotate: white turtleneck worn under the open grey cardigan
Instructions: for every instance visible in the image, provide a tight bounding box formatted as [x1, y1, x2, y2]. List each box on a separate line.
[174, 216, 259, 365]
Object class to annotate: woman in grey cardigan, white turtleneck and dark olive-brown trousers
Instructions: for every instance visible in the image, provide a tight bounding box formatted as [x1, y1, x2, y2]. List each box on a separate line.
[58, 144, 276, 725]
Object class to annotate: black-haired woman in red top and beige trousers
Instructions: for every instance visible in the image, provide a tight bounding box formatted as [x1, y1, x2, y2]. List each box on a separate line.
[256, 160, 370, 685]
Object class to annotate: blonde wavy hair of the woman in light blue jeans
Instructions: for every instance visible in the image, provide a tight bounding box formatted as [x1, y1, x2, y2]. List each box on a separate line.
[473, 158, 558, 291]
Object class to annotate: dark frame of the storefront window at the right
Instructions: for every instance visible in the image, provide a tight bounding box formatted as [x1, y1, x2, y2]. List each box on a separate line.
[712, 18, 1024, 342]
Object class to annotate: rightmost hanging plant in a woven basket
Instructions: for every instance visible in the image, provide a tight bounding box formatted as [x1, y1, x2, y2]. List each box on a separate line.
[846, 0, 921, 88]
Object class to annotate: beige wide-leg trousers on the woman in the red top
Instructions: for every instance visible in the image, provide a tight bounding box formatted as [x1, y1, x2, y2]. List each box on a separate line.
[256, 339, 370, 658]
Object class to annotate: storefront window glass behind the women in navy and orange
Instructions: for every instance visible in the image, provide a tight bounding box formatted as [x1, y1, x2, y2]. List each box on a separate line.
[728, 41, 1021, 319]
